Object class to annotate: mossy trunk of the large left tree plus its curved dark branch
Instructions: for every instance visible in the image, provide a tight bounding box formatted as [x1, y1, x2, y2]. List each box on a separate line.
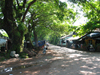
[2, 0, 36, 53]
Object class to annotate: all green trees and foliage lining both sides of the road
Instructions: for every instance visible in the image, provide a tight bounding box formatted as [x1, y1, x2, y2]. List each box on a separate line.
[0, 0, 100, 60]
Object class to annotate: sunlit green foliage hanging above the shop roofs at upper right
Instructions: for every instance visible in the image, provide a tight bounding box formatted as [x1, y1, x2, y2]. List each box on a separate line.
[69, 0, 100, 35]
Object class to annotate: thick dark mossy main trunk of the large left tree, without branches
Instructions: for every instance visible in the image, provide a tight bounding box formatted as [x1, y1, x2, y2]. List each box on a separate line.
[3, 0, 24, 53]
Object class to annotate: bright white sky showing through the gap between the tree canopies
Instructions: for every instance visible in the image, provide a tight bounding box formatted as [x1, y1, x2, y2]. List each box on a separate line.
[60, 0, 88, 26]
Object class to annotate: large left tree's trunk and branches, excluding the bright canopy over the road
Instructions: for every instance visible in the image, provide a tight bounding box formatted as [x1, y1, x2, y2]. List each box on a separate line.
[0, 0, 36, 53]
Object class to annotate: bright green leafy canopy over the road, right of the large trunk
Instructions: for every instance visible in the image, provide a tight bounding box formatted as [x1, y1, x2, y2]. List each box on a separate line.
[24, 1, 76, 45]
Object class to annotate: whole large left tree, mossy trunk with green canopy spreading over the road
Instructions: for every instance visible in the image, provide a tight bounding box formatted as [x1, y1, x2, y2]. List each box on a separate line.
[0, 0, 75, 53]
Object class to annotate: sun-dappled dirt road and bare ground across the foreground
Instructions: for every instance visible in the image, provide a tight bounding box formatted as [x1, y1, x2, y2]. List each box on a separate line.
[0, 45, 100, 75]
